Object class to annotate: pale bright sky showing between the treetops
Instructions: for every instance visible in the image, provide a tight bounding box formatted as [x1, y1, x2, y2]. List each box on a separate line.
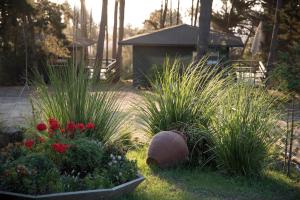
[51, 0, 222, 28]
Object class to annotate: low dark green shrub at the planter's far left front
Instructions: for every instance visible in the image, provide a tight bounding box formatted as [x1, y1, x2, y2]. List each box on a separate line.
[0, 153, 60, 194]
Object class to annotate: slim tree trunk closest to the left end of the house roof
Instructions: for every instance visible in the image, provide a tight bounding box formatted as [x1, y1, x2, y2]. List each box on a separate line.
[113, 0, 125, 82]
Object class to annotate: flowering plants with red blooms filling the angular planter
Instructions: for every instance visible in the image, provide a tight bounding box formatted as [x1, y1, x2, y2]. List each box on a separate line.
[0, 118, 137, 194]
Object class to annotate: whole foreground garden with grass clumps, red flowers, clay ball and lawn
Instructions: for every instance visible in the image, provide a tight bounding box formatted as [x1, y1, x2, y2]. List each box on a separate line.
[0, 58, 300, 200]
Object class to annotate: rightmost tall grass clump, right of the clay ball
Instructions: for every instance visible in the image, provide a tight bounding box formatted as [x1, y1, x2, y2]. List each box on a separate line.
[210, 84, 279, 176]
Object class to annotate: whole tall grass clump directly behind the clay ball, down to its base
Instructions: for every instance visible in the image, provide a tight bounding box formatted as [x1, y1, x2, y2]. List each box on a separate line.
[137, 58, 231, 165]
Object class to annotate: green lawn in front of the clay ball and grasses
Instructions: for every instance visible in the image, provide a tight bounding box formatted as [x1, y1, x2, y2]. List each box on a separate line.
[119, 149, 300, 200]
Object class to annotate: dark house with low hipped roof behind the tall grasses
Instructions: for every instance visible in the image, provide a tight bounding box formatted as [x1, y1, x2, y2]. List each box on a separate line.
[119, 24, 243, 86]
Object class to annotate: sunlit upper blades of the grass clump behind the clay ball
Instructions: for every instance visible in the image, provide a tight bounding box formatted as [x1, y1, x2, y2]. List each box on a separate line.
[137, 59, 226, 135]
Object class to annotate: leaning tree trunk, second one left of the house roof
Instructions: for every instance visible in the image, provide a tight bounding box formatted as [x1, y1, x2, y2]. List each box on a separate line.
[94, 0, 108, 80]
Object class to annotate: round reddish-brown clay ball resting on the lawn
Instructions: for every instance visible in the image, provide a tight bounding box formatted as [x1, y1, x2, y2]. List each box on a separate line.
[146, 131, 189, 168]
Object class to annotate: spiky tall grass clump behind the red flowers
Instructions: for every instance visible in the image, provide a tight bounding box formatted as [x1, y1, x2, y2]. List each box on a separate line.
[34, 65, 127, 145]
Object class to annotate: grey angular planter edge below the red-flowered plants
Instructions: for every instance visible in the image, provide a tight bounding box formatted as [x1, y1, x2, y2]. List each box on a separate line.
[0, 175, 145, 200]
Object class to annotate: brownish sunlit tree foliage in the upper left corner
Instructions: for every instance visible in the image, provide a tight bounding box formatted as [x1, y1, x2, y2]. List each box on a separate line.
[0, 0, 70, 85]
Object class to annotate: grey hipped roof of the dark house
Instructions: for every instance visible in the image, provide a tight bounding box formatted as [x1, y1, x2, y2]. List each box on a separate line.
[119, 24, 244, 47]
